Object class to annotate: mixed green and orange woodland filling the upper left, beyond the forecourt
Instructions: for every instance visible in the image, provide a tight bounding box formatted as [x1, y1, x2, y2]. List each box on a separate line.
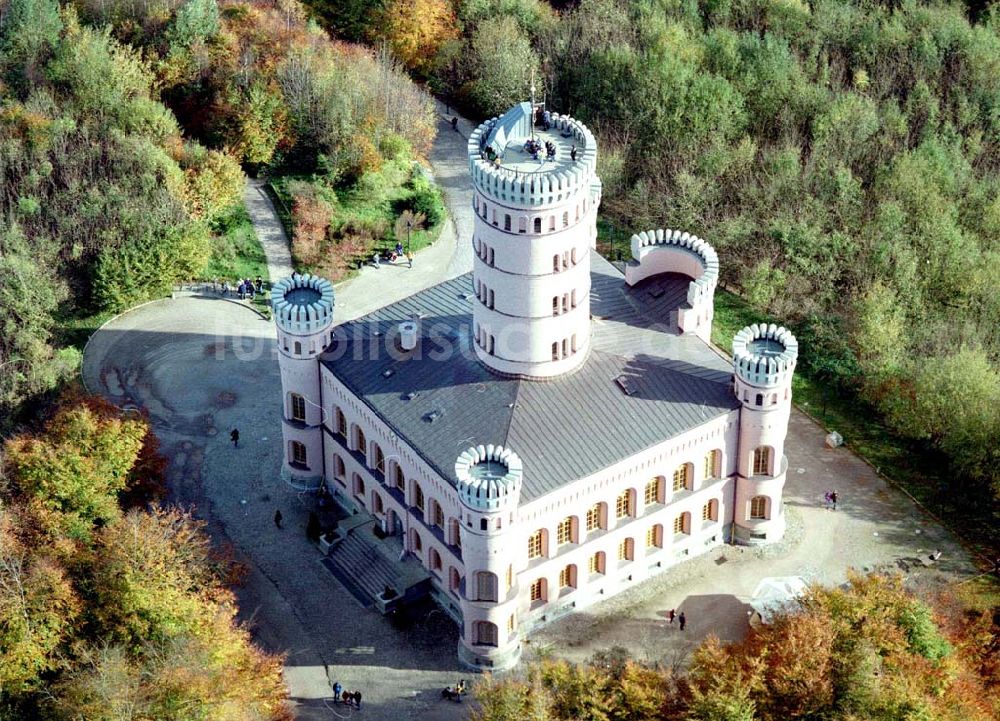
[0, 0, 440, 430]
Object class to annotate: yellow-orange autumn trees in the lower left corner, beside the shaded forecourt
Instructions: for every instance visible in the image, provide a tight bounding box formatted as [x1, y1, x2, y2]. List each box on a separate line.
[0, 398, 291, 721]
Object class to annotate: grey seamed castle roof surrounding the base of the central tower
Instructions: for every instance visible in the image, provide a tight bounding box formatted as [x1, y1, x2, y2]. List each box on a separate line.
[321, 253, 739, 502]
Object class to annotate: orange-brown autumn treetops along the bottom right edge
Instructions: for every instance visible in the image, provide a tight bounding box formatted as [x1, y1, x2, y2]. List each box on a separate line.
[472, 575, 1000, 721]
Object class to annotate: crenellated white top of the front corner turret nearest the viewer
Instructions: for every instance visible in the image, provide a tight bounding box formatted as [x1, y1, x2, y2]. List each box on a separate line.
[455, 443, 522, 512]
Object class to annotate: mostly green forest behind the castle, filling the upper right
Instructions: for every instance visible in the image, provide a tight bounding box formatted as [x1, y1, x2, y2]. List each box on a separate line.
[307, 0, 1000, 512]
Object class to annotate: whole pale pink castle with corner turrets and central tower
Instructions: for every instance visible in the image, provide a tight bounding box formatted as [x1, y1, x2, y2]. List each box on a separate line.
[272, 103, 798, 668]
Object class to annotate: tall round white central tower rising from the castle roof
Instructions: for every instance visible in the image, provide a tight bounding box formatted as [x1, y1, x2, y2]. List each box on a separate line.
[468, 103, 601, 378]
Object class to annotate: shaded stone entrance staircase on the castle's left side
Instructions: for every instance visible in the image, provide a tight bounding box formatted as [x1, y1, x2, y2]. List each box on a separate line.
[322, 519, 431, 613]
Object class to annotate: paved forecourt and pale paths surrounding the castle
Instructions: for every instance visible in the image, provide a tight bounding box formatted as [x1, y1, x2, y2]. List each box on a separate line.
[84, 102, 971, 720]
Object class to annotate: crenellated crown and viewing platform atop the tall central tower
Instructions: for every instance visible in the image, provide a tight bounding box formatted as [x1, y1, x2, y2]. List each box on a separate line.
[468, 103, 599, 208]
